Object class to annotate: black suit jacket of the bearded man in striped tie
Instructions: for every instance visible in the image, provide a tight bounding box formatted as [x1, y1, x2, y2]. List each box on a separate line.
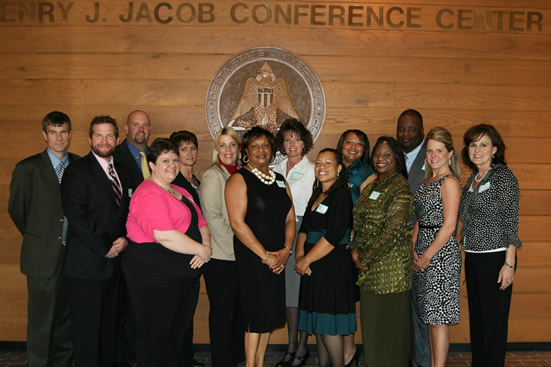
[61, 152, 130, 279]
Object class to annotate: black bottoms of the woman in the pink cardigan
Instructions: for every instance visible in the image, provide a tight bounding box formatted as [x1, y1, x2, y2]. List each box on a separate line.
[123, 254, 198, 367]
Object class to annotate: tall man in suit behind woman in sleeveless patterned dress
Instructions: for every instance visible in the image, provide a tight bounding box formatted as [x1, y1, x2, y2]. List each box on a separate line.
[396, 109, 430, 367]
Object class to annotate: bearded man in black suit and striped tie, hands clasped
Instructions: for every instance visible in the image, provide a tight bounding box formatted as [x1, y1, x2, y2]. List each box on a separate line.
[61, 116, 129, 367]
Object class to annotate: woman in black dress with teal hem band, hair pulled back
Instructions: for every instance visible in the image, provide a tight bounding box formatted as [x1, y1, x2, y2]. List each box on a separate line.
[295, 148, 356, 367]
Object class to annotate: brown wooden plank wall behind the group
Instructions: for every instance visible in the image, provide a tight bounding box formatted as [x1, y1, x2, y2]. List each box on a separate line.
[0, 0, 551, 344]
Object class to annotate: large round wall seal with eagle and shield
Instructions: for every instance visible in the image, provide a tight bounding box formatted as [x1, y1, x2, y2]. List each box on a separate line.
[206, 47, 325, 141]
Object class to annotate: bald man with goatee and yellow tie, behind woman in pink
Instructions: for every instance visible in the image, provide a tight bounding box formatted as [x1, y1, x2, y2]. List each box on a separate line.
[113, 110, 151, 366]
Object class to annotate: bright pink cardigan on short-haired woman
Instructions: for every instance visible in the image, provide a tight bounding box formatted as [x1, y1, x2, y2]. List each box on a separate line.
[126, 180, 207, 243]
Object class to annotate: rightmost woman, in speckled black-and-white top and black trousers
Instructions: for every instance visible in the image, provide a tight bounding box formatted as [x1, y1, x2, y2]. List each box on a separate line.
[459, 124, 521, 367]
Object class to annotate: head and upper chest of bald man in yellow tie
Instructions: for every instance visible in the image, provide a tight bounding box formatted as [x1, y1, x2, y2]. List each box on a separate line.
[114, 110, 151, 190]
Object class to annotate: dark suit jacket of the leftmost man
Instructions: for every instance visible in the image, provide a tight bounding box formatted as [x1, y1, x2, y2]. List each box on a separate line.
[8, 150, 80, 278]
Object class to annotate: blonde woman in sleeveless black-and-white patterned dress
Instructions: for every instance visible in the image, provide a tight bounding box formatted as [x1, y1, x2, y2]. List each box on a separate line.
[413, 127, 461, 367]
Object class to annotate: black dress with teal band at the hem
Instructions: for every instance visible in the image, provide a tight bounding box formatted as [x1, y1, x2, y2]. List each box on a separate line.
[298, 188, 356, 335]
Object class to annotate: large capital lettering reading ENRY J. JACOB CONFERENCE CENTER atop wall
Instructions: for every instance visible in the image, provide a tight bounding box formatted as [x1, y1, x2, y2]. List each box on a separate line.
[0, 0, 551, 33]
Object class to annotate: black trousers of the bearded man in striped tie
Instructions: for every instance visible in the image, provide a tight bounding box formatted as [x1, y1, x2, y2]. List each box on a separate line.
[65, 271, 120, 367]
